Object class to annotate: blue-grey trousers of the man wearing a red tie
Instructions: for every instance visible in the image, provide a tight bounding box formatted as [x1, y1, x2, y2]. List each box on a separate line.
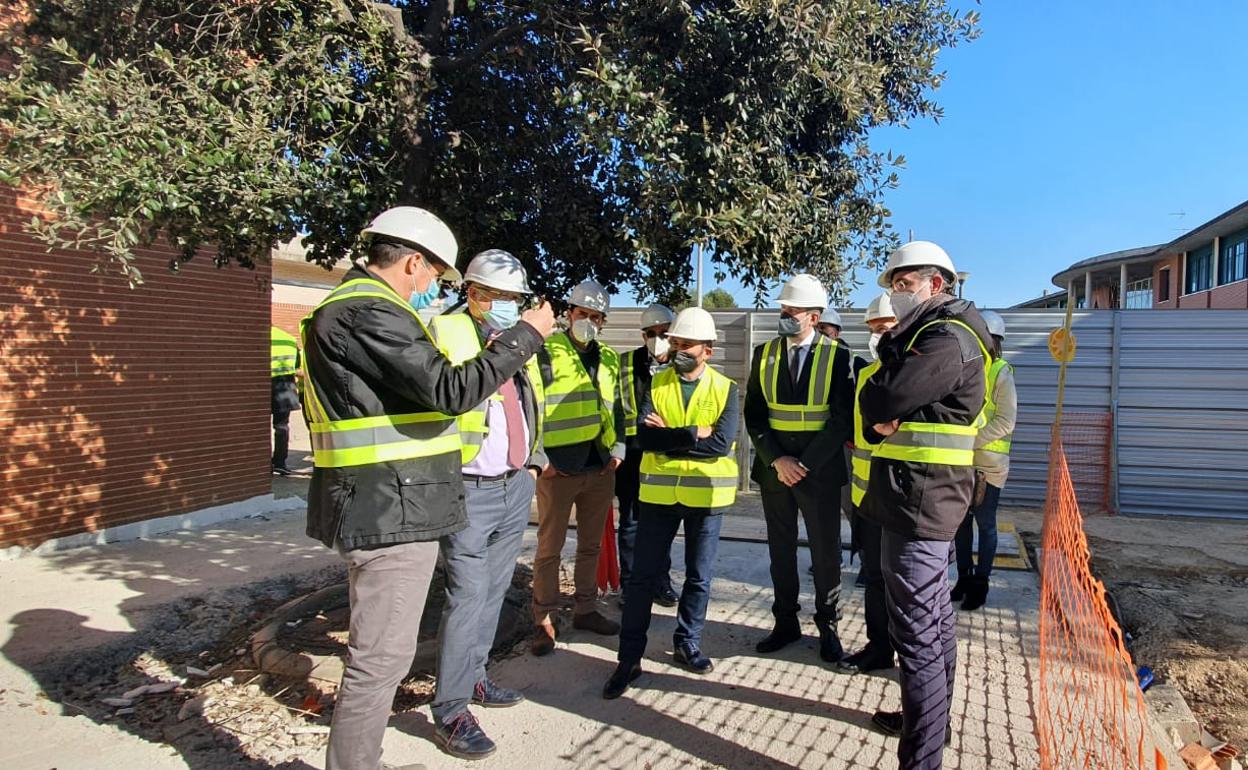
[429, 470, 537, 725]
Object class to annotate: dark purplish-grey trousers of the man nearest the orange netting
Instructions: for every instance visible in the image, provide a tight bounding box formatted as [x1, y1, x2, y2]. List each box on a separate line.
[880, 529, 957, 770]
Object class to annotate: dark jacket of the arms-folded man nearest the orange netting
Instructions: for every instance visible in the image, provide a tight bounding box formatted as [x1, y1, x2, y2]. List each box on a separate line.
[859, 295, 992, 540]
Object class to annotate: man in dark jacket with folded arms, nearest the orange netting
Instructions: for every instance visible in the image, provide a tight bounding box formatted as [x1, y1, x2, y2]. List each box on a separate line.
[857, 241, 992, 770]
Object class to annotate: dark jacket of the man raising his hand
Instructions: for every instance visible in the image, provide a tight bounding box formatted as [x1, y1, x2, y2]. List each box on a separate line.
[303, 267, 542, 550]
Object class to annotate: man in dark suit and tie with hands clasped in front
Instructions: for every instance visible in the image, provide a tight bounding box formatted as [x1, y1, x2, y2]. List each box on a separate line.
[744, 273, 854, 663]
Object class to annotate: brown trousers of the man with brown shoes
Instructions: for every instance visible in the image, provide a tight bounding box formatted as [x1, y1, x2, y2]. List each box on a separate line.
[533, 469, 615, 623]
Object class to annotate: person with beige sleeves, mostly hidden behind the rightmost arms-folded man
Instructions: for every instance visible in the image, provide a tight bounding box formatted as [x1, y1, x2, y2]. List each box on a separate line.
[950, 311, 1018, 610]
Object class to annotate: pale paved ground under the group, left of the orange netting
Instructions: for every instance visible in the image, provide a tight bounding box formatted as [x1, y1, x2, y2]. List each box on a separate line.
[0, 479, 1038, 770]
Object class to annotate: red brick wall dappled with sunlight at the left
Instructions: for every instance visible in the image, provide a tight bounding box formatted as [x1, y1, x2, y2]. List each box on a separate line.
[0, 187, 271, 547]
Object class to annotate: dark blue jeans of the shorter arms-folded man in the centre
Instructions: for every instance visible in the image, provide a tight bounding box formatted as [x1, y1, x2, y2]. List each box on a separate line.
[619, 503, 724, 663]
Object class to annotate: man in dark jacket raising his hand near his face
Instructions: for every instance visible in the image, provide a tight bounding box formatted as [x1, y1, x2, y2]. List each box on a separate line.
[301, 206, 554, 770]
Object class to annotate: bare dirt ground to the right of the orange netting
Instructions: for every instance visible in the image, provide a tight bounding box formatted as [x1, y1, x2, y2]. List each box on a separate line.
[1007, 510, 1248, 749]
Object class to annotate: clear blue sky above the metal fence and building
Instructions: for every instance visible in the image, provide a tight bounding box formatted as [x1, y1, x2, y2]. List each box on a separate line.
[648, 0, 1248, 307]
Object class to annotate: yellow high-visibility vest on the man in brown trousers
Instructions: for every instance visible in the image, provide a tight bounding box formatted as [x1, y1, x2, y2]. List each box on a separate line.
[544, 333, 620, 449]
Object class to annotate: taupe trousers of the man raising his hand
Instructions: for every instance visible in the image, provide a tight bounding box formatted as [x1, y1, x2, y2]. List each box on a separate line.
[326, 542, 438, 770]
